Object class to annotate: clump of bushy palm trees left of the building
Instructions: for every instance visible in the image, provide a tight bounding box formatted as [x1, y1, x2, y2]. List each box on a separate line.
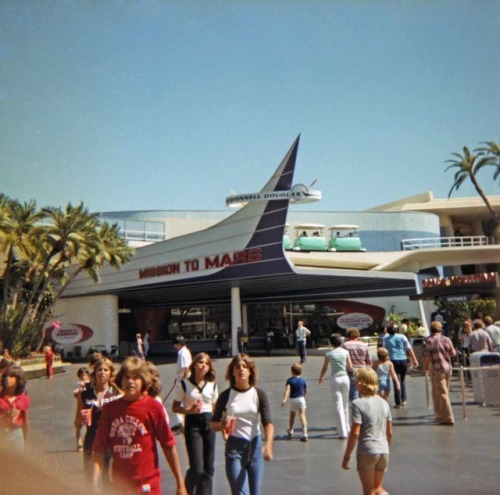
[0, 200, 134, 355]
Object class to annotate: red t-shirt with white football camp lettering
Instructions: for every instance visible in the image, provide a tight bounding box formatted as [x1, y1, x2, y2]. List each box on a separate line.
[92, 396, 175, 494]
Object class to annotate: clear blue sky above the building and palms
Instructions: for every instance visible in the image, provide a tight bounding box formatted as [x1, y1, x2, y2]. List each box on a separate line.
[0, 0, 500, 215]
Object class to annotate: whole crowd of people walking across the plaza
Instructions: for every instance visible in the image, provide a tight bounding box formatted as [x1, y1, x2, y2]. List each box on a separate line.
[0, 316, 500, 495]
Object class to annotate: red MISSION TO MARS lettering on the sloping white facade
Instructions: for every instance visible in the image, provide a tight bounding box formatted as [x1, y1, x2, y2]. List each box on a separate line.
[139, 248, 262, 278]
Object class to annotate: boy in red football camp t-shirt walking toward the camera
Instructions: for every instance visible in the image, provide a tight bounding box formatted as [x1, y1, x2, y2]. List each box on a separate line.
[92, 357, 187, 495]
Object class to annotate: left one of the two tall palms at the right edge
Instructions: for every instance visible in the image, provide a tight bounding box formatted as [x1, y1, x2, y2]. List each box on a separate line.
[446, 146, 500, 224]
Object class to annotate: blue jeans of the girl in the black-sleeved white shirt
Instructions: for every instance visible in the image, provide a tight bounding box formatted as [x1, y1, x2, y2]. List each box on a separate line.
[226, 435, 264, 495]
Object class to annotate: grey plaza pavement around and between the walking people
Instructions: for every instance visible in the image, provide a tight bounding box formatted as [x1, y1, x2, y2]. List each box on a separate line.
[13, 351, 500, 495]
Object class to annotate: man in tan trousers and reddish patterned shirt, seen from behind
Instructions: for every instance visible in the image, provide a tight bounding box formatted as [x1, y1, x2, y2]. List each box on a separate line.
[424, 321, 457, 425]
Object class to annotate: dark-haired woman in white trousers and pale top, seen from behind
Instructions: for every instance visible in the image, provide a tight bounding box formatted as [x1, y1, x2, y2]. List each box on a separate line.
[319, 333, 352, 439]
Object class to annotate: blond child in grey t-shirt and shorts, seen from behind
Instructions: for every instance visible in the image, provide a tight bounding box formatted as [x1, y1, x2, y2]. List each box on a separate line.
[342, 368, 392, 495]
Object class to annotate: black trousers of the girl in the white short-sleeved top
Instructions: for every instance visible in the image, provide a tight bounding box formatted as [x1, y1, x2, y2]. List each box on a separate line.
[184, 413, 216, 495]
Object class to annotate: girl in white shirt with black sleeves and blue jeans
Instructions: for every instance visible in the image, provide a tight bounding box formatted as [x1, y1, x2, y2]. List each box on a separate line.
[211, 354, 274, 495]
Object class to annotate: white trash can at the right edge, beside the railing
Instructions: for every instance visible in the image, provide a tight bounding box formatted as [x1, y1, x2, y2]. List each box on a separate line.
[470, 352, 500, 406]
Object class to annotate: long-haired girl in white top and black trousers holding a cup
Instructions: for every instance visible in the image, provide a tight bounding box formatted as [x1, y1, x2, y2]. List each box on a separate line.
[172, 352, 219, 495]
